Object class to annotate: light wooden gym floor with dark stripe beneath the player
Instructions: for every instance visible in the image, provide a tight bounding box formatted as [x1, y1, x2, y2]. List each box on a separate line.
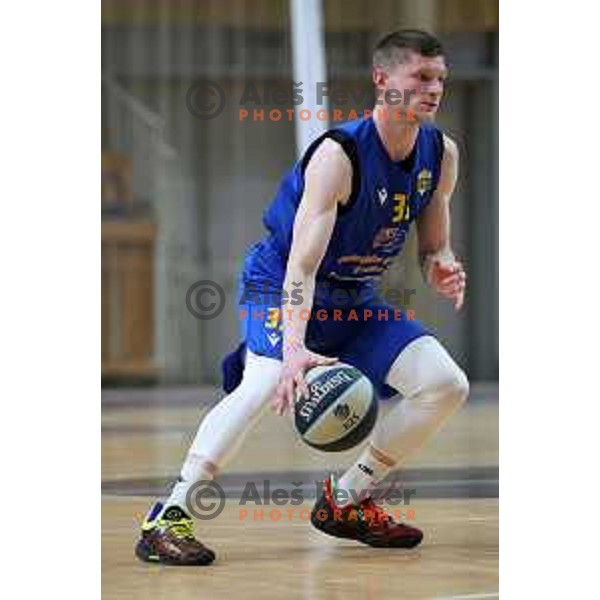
[102, 385, 498, 600]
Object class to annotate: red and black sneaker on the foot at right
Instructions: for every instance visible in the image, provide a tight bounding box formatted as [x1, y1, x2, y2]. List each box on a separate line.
[310, 476, 423, 548]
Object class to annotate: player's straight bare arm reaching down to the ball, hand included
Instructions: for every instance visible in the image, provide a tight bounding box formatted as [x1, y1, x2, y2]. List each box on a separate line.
[274, 139, 352, 414]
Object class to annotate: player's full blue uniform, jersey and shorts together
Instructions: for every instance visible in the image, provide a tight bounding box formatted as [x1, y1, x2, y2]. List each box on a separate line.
[223, 118, 443, 396]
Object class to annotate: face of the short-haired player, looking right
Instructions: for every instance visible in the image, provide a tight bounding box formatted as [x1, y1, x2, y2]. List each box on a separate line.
[373, 52, 448, 121]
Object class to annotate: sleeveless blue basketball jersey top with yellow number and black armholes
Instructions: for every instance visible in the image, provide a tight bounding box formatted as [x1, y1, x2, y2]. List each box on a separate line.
[244, 118, 443, 302]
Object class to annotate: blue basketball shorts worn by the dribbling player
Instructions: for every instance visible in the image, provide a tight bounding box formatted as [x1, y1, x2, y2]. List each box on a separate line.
[223, 280, 432, 397]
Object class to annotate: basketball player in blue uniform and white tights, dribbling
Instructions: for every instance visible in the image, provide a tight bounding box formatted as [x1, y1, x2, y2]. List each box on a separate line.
[136, 30, 468, 565]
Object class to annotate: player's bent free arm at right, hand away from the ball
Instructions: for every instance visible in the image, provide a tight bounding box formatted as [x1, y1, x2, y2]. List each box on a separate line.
[417, 136, 466, 310]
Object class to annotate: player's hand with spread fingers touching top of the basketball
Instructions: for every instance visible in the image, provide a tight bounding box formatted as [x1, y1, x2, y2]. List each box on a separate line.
[273, 347, 338, 415]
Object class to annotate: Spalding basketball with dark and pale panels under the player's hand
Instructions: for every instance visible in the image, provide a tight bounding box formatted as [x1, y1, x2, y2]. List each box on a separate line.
[295, 363, 378, 452]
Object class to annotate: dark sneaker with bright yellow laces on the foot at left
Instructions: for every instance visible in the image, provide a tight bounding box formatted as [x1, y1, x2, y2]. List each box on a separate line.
[135, 502, 215, 567]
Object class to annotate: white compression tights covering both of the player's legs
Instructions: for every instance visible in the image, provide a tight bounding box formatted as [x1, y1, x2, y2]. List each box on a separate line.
[167, 336, 468, 507]
